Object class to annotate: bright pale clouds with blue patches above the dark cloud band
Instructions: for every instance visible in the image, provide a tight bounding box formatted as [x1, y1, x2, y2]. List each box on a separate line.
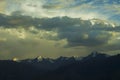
[1, 0, 117, 24]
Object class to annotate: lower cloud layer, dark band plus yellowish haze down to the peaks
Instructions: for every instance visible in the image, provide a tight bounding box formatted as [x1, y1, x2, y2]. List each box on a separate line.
[0, 13, 120, 59]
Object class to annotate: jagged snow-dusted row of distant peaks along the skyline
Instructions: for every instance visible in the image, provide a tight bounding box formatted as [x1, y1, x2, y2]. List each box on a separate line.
[19, 51, 109, 63]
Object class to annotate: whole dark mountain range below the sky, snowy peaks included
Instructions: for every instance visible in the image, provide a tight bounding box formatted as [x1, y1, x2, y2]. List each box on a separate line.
[0, 52, 120, 80]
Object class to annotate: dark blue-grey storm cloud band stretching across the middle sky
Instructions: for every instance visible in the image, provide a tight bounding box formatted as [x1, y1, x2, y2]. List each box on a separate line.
[0, 13, 120, 47]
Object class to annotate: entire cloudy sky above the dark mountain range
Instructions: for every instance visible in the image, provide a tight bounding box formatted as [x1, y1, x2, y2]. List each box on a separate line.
[0, 0, 120, 59]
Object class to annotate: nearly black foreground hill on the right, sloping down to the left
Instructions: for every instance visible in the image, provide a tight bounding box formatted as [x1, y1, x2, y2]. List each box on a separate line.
[40, 54, 120, 80]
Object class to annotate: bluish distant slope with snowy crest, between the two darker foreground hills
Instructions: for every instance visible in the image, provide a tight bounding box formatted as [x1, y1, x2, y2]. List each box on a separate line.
[21, 56, 76, 71]
